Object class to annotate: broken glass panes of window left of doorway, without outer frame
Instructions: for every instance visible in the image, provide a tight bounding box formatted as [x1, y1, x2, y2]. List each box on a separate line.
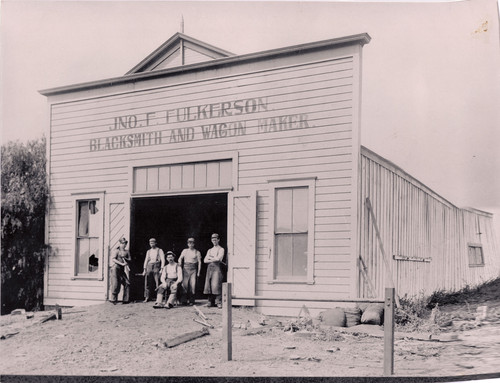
[75, 199, 102, 277]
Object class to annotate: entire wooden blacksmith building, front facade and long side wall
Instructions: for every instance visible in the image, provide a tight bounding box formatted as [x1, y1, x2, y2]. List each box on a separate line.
[41, 33, 499, 315]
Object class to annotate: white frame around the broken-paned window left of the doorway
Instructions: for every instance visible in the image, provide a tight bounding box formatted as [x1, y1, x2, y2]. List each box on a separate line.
[71, 192, 105, 281]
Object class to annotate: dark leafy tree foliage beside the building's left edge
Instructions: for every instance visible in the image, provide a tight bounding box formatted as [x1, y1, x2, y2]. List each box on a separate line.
[1, 137, 48, 314]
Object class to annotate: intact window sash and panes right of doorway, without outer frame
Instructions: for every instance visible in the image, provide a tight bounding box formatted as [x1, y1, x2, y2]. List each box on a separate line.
[274, 187, 309, 279]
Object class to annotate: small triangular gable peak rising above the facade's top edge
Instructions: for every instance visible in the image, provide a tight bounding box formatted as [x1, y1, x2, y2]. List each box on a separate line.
[126, 32, 234, 74]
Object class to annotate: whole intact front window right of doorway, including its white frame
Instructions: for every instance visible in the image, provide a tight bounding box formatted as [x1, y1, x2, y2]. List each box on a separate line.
[269, 178, 316, 284]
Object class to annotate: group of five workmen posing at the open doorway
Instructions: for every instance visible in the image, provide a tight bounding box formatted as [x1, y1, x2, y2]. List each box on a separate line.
[110, 233, 224, 309]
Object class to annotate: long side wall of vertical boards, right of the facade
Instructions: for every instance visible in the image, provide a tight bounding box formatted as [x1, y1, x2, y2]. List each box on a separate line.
[359, 148, 500, 297]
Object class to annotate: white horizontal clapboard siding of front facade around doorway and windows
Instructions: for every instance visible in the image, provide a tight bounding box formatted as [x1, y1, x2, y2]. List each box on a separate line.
[48, 44, 359, 306]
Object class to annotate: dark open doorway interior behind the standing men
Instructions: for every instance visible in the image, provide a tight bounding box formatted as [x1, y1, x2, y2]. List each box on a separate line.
[130, 193, 227, 300]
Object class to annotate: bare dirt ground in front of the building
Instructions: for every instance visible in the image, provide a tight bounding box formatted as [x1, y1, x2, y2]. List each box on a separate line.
[0, 301, 500, 377]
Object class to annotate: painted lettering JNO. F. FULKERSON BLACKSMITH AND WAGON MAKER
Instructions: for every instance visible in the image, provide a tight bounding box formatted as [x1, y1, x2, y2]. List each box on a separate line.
[90, 97, 311, 152]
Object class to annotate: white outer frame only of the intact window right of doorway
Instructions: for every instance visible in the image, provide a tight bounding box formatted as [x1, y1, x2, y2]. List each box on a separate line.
[268, 177, 316, 284]
